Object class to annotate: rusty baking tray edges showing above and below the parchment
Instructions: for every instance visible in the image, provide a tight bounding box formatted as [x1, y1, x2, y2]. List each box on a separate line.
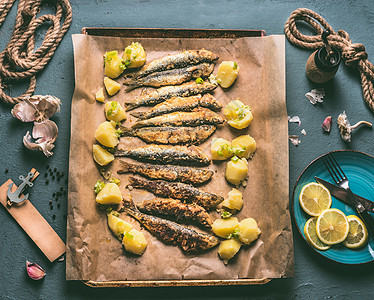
[81, 27, 271, 288]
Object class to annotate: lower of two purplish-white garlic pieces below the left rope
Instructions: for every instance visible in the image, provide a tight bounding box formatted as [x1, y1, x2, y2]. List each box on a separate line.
[23, 120, 58, 157]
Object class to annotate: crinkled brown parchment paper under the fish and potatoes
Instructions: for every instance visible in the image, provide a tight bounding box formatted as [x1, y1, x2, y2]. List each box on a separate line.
[66, 35, 294, 281]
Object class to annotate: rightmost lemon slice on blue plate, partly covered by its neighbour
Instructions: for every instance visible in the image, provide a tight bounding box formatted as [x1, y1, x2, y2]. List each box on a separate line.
[343, 215, 368, 249]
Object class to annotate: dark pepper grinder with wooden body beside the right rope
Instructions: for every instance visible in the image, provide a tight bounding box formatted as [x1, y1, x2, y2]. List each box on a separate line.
[305, 29, 341, 83]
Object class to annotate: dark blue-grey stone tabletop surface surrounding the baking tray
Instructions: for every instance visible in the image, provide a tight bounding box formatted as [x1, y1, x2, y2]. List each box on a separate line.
[0, 0, 374, 299]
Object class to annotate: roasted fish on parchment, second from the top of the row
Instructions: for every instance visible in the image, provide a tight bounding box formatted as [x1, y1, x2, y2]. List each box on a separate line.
[124, 63, 214, 91]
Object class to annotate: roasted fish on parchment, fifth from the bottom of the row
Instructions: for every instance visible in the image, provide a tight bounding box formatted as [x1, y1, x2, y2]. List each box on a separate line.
[114, 145, 210, 166]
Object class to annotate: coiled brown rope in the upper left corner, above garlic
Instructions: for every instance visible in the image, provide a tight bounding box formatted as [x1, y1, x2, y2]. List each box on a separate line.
[0, 0, 72, 104]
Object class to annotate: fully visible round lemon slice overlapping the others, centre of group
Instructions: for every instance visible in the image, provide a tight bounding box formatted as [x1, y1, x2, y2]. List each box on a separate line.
[316, 208, 349, 245]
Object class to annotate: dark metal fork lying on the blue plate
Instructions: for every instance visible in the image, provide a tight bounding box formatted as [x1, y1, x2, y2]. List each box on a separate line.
[322, 153, 374, 238]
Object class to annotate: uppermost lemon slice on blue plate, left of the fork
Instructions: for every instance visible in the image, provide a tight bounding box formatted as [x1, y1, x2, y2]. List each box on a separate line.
[299, 182, 331, 217]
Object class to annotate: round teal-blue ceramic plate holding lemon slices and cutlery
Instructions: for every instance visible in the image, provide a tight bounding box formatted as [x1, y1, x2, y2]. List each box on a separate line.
[292, 150, 374, 265]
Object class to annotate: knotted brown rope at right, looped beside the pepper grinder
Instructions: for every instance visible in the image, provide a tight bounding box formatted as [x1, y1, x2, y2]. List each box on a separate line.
[284, 8, 374, 112]
